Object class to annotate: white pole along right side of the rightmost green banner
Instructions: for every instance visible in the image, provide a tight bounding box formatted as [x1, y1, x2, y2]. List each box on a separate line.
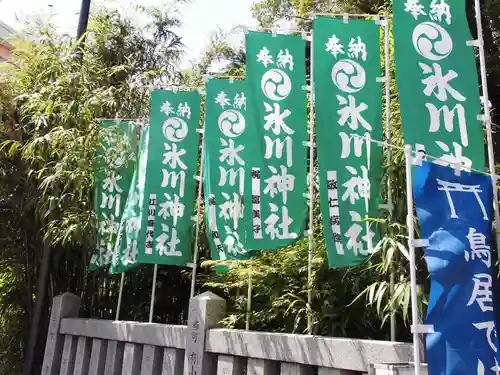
[474, 0, 500, 255]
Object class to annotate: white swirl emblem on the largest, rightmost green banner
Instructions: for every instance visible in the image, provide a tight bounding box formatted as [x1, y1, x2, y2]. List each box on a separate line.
[412, 22, 453, 61]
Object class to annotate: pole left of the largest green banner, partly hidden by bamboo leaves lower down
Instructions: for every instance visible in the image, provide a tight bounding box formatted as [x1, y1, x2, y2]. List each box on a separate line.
[384, 13, 396, 341]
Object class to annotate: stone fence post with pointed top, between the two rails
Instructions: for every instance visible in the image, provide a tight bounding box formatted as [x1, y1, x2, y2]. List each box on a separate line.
[184, 292, 226, 375]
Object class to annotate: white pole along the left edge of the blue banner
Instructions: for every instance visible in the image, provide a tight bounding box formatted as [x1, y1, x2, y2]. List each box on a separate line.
[405, 145, 420, 375]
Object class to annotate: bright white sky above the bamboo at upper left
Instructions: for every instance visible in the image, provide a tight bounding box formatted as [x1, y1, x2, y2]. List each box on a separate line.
[0, 0, 256, 67]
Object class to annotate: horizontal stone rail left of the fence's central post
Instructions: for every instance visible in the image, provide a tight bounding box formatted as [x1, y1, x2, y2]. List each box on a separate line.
[60, 319, 186, 349]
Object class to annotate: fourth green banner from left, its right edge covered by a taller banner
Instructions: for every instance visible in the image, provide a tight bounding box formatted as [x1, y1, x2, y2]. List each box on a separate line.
[204, 79, 252, 260]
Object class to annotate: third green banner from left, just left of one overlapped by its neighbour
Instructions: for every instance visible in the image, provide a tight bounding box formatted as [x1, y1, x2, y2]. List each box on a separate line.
[137, 90, 201, 266]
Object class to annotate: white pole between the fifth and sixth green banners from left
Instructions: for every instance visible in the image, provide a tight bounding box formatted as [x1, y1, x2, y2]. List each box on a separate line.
[307, 30, 315, 335]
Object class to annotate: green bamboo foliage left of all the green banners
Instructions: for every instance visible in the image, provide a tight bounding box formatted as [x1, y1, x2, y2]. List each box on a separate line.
[0, 7, 188, 374]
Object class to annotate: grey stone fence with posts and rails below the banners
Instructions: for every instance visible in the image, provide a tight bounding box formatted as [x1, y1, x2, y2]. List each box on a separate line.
[42, 292, 426, 375]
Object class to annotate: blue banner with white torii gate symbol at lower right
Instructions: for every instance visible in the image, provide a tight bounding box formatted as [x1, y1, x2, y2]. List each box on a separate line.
[414, 162, 500, 375]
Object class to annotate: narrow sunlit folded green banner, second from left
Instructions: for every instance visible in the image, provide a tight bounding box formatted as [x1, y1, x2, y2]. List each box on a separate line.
[110, 127, 149, 274]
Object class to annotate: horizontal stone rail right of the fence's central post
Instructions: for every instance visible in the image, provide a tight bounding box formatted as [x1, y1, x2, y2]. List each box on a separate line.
[205, 329, 413, 372]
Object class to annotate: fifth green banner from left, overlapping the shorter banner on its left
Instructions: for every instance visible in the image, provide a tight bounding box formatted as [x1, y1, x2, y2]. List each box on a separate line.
[244, 31, 308, 250]
